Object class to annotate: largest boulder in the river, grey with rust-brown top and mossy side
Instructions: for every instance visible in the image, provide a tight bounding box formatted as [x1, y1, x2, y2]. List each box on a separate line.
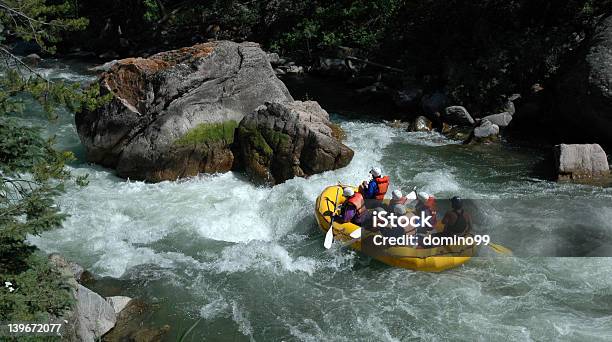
[75, 41, 292, 181]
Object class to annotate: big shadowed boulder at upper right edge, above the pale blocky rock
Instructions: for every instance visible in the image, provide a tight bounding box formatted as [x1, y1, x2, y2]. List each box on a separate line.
[555, 16, 612, 144]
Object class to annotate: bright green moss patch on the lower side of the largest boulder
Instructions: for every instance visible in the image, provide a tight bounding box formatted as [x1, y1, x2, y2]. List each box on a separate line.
[174, 120, 238, 146]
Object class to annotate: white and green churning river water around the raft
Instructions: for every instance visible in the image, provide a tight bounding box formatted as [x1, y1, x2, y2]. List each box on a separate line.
[30, 60, 612, 341]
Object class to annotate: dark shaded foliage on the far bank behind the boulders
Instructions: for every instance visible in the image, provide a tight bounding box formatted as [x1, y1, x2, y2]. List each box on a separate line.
[65, 0, 612, 116]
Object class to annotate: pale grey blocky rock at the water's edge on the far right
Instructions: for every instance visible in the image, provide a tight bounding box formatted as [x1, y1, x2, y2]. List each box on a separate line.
[554, 144, 610, 180]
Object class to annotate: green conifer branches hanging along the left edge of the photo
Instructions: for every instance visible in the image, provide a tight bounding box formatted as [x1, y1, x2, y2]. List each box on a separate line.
[0, 0, 108, 322]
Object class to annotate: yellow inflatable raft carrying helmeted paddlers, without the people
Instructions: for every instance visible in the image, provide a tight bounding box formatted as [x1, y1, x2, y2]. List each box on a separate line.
[315, 185, 476, 272]
